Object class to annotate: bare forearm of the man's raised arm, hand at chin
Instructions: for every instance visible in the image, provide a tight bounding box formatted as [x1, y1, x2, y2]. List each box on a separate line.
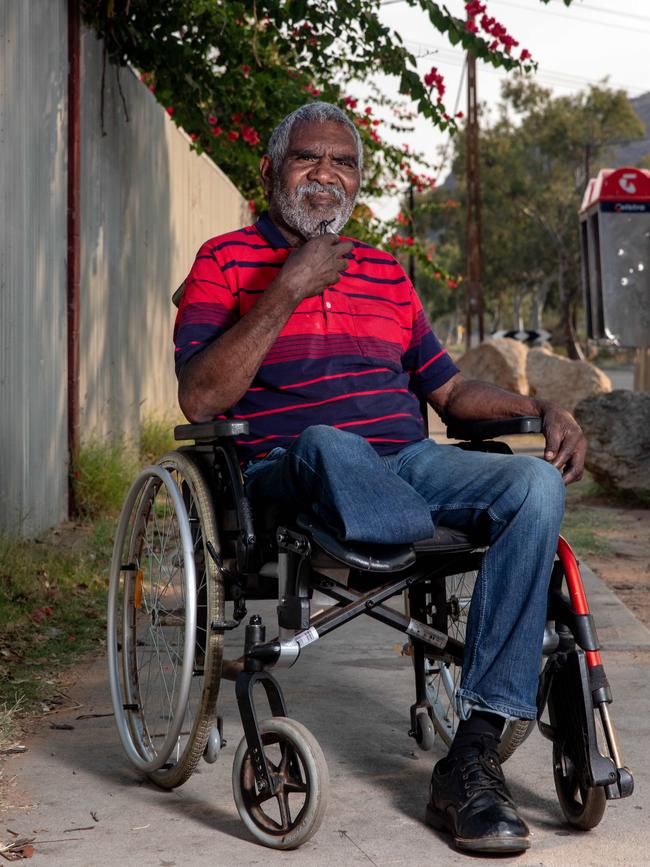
[178, 281, 296, 422]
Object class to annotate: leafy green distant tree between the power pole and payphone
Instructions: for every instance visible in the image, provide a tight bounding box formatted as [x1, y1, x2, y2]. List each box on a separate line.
[415, 76, 645, 358]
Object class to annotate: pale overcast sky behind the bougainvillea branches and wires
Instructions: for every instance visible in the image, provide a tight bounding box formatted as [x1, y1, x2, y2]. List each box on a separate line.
[355, 0, 650, 216]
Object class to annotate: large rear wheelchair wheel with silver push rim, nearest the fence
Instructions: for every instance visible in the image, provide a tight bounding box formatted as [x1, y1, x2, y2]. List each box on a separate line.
[108, 452, 224, 788]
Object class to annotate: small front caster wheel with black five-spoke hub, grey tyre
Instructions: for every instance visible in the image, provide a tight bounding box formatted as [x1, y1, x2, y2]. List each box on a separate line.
[232, 716, 329, 849]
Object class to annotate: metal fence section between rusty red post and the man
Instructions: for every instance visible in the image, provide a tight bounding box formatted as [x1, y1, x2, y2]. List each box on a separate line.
[80, 32, 249, 441]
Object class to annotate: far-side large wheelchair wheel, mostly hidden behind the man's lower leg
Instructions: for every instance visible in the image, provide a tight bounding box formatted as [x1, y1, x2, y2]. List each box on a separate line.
[424, 571, 535, 762]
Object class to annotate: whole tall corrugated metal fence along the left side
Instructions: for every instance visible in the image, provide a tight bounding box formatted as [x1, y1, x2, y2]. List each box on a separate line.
[0, 0, 248, 536]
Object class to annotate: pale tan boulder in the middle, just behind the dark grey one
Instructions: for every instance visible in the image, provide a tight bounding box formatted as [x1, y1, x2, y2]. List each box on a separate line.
[526, 349, 612, 412]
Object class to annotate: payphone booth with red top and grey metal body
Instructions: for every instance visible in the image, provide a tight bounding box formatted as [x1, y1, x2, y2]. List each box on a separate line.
[580, 168, 650, 347]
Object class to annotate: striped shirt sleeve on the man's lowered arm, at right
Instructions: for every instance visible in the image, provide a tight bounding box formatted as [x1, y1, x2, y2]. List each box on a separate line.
[402, 286, 459, 400]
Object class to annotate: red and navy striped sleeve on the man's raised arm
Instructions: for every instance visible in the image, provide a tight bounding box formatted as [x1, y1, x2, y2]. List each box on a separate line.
[174, 241, 239, 376]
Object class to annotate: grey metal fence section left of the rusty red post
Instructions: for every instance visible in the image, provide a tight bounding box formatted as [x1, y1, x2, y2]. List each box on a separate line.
[0, 0, 68, 536]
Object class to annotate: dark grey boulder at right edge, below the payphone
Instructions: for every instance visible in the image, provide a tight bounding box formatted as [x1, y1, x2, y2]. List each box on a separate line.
[575, 390, 650, 493]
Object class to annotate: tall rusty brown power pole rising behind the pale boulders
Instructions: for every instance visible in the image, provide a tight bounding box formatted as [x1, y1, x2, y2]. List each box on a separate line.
[465, 51, 484, 349]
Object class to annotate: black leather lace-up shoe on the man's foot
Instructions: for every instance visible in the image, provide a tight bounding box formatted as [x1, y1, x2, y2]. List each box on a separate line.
[426, 742, 530, 853]
